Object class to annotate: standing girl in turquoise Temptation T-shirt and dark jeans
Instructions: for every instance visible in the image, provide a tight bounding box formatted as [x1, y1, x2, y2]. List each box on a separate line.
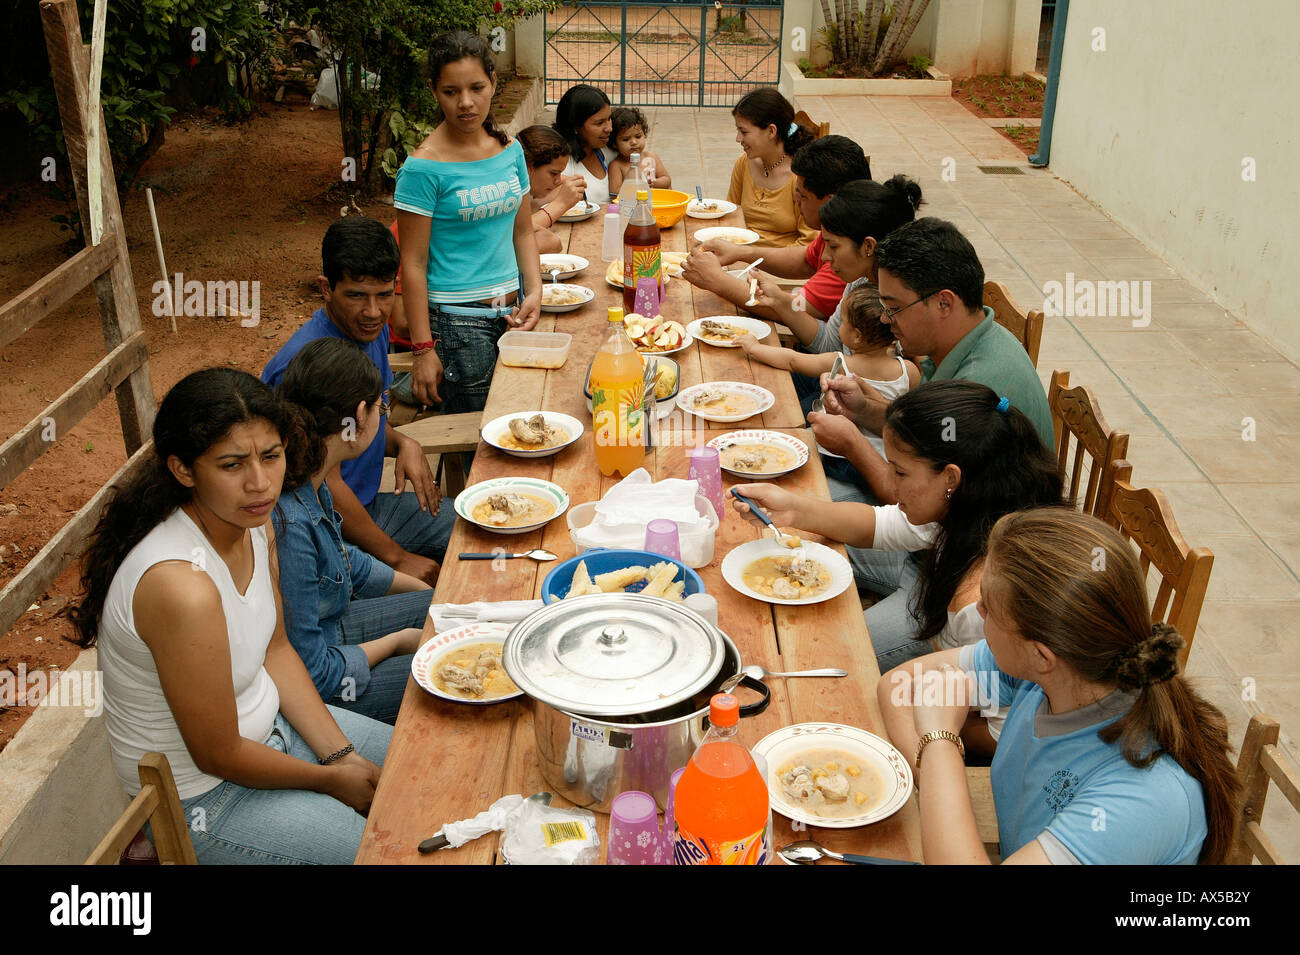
[393, 32, 542, 413]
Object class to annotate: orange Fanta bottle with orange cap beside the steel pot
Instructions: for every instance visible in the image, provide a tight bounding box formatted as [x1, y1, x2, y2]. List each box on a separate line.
[672, 693, 772, 865]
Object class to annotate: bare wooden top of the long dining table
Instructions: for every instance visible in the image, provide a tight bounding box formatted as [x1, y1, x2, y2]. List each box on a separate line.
[356, 205, 920, 864]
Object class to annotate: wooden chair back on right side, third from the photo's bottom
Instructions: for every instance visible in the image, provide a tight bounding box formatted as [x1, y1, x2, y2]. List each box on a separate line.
[1048, 370, 1128, 520]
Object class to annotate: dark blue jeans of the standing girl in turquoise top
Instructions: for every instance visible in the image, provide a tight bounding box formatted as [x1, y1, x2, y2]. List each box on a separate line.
[429, 301, 510, 414]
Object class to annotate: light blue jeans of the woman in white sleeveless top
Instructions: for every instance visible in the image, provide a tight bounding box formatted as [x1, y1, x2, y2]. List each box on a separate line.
[181, 707, 393, 865]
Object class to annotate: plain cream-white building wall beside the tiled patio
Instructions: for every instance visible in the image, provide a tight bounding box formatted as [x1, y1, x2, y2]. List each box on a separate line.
[1050, 0, 1300, 360]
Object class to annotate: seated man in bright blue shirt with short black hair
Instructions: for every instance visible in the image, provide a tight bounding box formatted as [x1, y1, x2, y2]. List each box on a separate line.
[261, 217, 455, 585]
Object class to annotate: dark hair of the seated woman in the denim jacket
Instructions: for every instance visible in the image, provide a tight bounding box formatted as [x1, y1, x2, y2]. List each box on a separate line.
[276, 338, 384, 491]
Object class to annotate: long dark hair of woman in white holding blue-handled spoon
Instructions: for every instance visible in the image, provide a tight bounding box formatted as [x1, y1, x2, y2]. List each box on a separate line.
[884, 381, 1062, 639]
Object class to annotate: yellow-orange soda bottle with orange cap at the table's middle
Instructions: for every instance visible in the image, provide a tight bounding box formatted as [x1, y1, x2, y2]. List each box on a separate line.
[592, 308, 646, 477]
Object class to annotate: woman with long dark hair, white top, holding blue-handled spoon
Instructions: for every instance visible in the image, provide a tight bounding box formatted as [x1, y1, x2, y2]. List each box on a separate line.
[737, 381, 1061, 672]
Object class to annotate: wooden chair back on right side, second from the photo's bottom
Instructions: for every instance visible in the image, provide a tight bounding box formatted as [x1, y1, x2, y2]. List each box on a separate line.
[1106, 470, 1214, 669]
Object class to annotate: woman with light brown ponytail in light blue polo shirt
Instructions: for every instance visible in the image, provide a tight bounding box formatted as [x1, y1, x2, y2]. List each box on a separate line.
[878, 508, 1238, 865]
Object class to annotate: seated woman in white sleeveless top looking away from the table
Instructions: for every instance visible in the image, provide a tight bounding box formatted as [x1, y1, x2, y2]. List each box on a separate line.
[72, 368, 391, 864]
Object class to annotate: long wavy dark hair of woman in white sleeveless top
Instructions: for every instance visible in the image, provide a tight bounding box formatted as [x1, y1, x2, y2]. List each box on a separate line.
[68, 368, 290, 647]
